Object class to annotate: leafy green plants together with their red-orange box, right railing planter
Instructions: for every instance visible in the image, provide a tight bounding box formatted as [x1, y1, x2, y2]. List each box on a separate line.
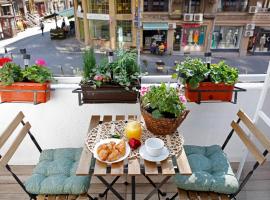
[173, 58, 239, 102]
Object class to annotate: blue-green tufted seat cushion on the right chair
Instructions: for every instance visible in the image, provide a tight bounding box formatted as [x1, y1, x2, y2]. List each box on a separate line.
[174, 145, 239, 194]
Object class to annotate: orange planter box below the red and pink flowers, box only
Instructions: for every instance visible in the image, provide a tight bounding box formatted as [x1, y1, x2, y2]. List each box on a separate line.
[0, 82, 50, 104]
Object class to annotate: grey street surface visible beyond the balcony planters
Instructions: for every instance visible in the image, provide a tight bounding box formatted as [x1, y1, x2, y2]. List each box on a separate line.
[0, 22, 270, 76]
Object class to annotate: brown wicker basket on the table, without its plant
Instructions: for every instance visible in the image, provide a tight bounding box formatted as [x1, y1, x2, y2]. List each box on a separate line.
[141, 107, 189, 135]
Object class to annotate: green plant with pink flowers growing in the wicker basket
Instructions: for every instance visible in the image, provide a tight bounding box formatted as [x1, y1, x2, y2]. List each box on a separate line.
[140, 83, 187, 119]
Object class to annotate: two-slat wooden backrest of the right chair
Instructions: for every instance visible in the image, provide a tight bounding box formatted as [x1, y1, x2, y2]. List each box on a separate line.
[231, 110, 270, 164]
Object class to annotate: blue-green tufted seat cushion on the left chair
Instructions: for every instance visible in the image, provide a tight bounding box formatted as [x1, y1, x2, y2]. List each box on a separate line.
[24, 148, 90, 195]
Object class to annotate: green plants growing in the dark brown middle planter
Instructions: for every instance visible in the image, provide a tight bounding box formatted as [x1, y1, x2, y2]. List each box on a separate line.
[82, 49, 141, 90]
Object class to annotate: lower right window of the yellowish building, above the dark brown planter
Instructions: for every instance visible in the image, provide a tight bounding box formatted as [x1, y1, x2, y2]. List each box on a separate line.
[116, 20, 132, 42]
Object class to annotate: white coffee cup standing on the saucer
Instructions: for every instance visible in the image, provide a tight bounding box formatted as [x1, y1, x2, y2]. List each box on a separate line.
[145, 138, 164, 157]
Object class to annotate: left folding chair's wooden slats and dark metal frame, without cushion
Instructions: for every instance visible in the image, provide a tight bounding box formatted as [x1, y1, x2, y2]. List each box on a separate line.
[0, 112, 94, 200]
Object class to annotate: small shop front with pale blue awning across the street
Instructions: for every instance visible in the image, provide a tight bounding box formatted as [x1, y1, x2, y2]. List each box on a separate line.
[143, 22, 169, 50]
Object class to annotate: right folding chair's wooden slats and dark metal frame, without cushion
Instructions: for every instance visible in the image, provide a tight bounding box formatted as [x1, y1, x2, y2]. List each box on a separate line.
[174, 110, 270, 200]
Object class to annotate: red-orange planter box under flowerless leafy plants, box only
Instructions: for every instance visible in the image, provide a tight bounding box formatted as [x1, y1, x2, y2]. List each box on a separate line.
[185, 82, 234, 102]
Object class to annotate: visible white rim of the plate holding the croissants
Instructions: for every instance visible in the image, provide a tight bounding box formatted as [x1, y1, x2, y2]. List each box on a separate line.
[93, 138, 130, 164]
